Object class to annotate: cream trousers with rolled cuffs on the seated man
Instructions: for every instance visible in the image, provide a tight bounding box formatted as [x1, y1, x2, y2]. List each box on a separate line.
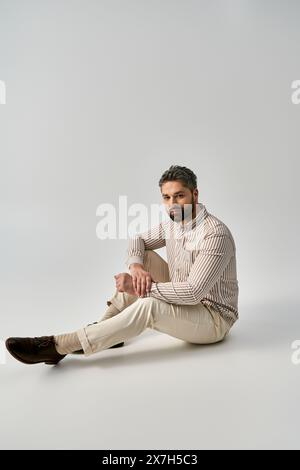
[76, 250, 230, 356]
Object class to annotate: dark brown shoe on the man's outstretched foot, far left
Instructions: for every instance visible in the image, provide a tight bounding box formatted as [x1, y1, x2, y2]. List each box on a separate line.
[5, 335, 66, 365]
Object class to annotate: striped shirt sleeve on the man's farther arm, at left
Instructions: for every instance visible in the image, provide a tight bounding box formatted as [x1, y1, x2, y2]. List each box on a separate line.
[125, 222, 166, 268]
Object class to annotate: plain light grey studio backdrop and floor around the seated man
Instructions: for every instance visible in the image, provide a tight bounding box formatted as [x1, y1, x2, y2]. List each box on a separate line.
[0, 0, 300, 449]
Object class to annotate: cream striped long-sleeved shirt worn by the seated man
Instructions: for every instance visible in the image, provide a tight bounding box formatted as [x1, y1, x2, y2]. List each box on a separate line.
[125, 203, 239, 325]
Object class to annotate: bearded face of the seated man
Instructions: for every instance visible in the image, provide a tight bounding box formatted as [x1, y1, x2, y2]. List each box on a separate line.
[161, 181, 198, 222]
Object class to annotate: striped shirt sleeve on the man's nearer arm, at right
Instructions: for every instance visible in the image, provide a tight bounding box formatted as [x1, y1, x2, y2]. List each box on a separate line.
[148, 234, 234, 305]
